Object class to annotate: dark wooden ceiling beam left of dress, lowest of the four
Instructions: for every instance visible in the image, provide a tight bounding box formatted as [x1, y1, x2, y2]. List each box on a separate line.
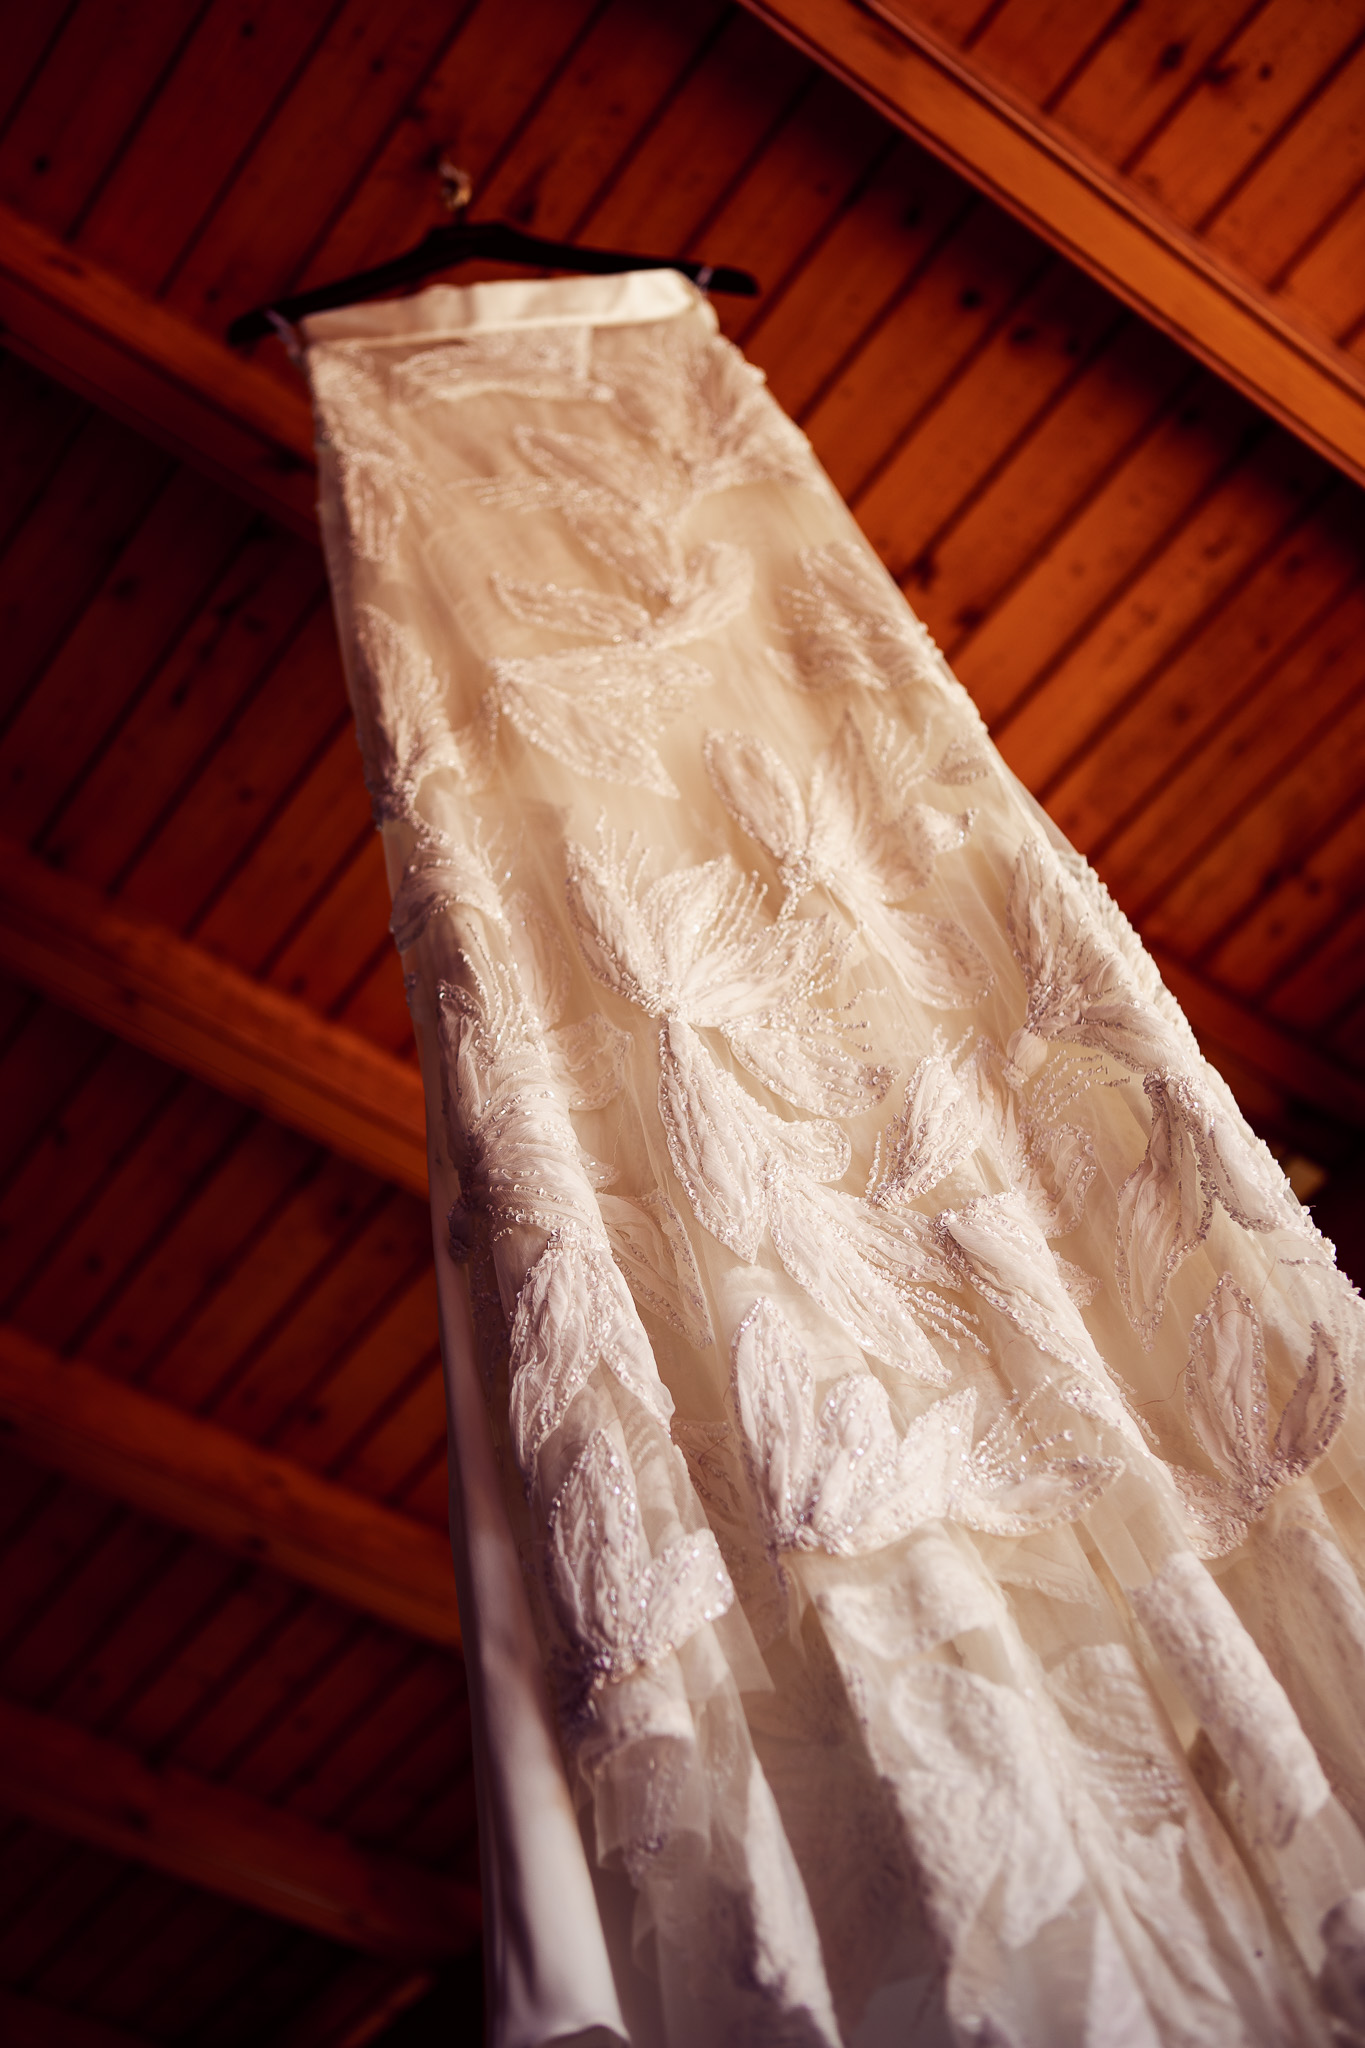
[0, 1700, 479, 1962]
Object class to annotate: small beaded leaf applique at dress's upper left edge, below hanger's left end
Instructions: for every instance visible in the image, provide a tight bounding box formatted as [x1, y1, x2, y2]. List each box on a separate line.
[309, 342, 436, 565]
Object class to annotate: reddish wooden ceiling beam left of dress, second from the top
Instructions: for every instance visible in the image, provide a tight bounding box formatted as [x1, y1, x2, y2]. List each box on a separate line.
[0, 840, 426, 1194]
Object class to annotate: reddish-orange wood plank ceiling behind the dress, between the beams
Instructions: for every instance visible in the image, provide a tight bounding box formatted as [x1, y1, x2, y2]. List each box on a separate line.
[0, 0, 1365, 2048]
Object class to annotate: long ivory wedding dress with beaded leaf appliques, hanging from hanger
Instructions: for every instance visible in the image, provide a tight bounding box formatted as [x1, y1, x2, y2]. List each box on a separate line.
[307, 272, 1365, 2048]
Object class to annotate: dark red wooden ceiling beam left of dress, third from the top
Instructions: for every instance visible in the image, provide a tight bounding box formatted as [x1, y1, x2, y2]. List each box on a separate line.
[0, 1325, 460, 1649]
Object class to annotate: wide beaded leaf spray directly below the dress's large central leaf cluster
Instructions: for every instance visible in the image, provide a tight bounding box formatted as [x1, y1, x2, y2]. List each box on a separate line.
[731, 1296, 1121, 1556]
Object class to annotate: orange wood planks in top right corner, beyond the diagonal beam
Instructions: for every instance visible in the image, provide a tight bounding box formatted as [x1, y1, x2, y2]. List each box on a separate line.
[890, 0, 1365, 366]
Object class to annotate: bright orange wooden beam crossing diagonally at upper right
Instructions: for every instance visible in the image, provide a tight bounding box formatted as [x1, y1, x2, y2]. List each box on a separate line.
[745, 0, 1365, 483]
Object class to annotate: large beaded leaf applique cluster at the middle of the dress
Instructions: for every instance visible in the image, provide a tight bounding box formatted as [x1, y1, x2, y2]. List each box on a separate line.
[569, 864, 986, 1384]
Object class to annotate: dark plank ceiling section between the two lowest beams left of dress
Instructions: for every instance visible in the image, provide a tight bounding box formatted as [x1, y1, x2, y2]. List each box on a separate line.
[0, 1454, 471, 1866]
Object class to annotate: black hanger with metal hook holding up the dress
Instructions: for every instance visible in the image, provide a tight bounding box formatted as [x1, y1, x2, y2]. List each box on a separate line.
[227, 160, 759, 348]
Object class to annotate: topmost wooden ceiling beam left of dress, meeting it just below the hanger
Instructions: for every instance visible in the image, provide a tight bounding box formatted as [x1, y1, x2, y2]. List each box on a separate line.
[0, 205, 317, 539]
